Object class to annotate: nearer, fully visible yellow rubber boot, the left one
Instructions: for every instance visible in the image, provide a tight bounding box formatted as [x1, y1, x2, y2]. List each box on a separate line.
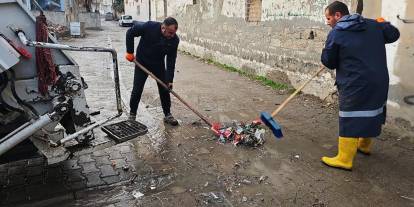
[322, 137, 358, 170]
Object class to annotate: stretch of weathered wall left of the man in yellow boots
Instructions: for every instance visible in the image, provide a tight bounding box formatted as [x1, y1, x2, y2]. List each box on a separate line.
[158, 0, 351, 98]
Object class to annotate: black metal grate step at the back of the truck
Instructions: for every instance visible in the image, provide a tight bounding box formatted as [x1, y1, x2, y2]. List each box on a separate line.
[102, 120, 148, 143]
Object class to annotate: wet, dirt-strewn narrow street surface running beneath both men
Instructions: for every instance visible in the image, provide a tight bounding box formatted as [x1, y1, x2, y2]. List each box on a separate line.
[6, 21, 414, 207]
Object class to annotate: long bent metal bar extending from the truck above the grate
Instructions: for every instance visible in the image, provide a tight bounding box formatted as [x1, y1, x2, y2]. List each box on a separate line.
[13, 29, 122, 114]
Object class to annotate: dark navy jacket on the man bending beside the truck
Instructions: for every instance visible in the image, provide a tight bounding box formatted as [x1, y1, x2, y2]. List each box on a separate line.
[126, 21, 180, 83]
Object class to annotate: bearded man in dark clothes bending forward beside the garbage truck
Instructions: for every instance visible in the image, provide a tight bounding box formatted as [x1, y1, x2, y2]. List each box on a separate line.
[125, 17, 180, 126]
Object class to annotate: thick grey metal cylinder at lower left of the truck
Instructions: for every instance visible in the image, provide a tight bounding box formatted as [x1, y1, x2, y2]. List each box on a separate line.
[0, 112, 56, 155]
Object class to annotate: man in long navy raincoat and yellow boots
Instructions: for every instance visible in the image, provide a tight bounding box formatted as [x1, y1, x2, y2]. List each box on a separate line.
[321, 1, 400, 170]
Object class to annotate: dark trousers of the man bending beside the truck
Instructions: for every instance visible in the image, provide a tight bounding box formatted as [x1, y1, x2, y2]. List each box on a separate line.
[129, 66, 171, 115]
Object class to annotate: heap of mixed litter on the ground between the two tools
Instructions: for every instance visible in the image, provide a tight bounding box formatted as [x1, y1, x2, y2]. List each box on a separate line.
[216, 121, 266, 147]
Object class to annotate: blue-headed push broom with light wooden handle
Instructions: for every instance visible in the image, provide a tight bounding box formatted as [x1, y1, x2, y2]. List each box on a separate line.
[260, 66, 324, 138]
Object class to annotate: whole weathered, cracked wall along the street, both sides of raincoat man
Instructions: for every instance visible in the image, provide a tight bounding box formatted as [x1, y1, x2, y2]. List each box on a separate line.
[124, 0, 414, 128]
